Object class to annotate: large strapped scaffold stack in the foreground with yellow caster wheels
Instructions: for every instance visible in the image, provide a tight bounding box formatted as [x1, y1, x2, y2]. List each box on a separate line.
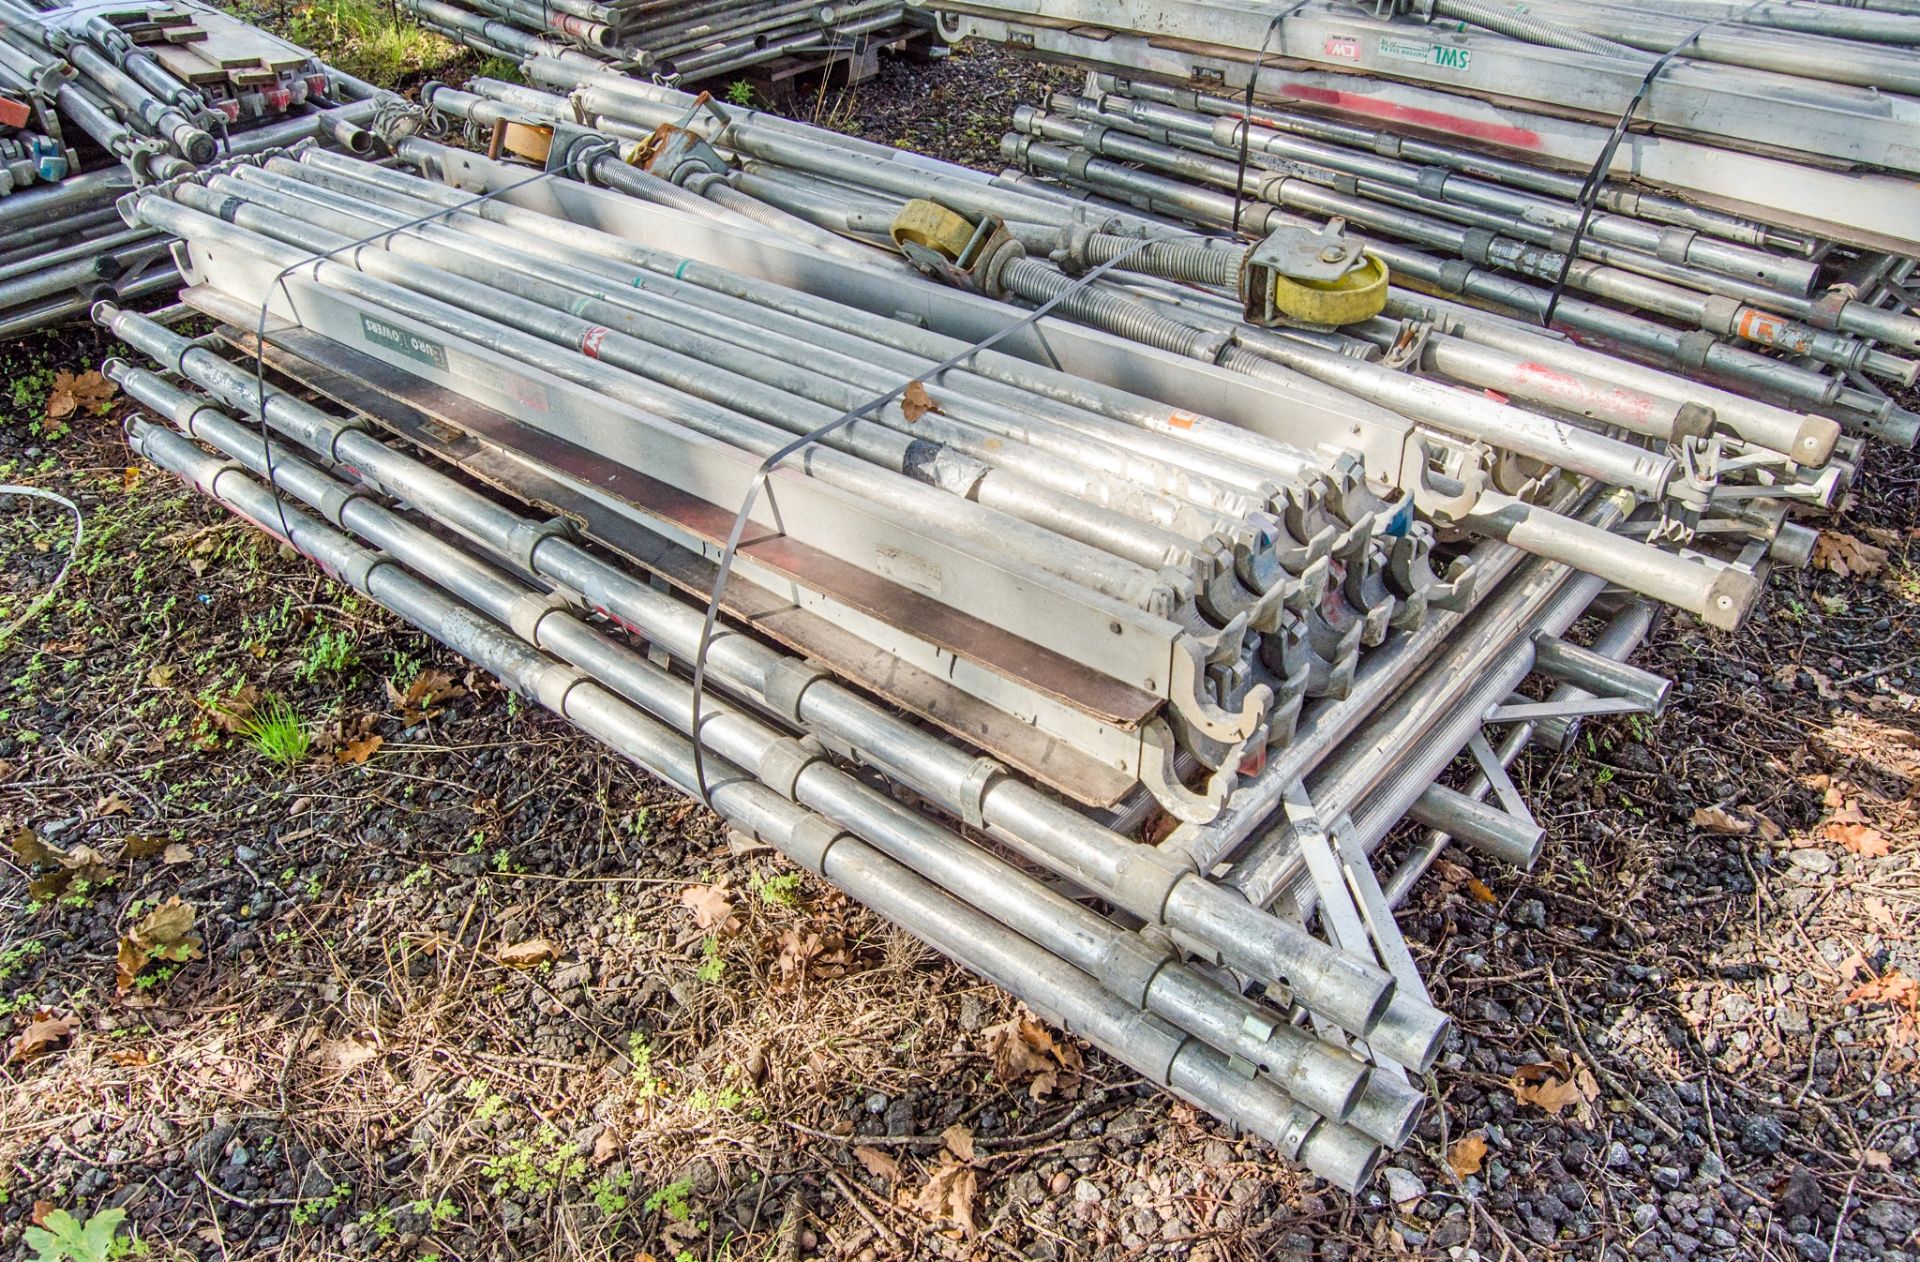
[96, 46, 1904, 1189]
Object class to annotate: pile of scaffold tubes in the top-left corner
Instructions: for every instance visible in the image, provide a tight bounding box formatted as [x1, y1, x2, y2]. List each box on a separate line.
[0, 0, 385, 338]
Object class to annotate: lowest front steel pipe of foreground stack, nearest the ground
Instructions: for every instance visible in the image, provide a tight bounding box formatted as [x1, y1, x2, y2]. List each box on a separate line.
[129, 419, 1377, 1189]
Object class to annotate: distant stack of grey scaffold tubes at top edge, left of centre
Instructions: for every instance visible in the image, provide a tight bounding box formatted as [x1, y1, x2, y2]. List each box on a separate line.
[399, 0, 925, 83]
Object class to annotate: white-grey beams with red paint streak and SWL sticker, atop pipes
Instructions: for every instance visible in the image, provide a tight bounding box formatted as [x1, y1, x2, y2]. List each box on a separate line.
[925, 0, 1920, 276]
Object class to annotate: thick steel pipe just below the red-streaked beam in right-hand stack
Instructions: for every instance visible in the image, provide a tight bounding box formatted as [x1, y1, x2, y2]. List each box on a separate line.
[1052, 92, 1820, 296]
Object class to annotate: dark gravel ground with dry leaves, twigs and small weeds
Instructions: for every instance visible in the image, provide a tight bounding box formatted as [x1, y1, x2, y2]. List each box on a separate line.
[0, 34, 1920, 1262]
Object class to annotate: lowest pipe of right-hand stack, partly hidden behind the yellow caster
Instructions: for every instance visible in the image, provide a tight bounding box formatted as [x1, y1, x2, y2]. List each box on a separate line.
[1018, 136, 1839, 416]
